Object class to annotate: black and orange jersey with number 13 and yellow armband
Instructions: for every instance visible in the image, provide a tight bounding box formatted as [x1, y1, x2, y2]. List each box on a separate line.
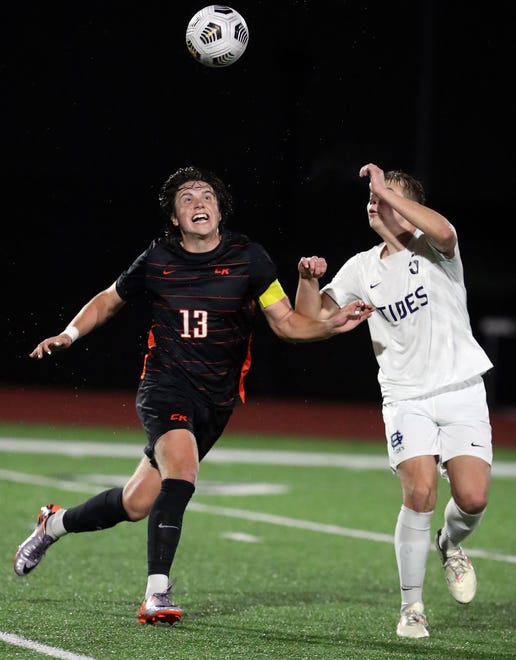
[116, 231, 285, 408]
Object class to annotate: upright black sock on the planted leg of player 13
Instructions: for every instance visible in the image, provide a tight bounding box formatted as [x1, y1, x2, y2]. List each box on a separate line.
[147, 479, 195, 575]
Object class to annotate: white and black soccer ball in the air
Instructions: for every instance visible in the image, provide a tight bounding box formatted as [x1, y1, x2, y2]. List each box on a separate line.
[186, 5, 249, 68]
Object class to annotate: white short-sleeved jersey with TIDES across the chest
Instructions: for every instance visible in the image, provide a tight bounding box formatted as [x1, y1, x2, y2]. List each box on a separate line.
[322, 230, 493, 403]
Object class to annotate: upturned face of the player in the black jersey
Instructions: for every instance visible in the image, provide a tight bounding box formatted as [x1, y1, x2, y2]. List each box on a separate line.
[172, 181, 220, 236]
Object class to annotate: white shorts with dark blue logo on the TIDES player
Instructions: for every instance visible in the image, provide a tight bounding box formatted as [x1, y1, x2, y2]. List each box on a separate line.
[382, 376, 493, 479]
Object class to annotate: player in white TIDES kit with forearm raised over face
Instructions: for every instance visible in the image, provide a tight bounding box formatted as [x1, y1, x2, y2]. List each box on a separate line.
[296, 163, 493, 638]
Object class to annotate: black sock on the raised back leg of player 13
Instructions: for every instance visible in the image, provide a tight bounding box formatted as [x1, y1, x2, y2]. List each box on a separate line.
[63, 488, 129, 532]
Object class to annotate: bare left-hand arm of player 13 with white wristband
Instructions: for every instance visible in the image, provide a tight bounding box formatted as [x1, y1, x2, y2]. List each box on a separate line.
[30, 283, 125, 359]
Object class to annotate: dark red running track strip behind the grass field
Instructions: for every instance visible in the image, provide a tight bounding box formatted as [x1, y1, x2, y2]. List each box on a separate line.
[0, 386, 516, 447]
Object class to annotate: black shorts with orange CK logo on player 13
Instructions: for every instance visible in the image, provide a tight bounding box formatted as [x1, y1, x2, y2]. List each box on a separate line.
[136, 380, 233, 467]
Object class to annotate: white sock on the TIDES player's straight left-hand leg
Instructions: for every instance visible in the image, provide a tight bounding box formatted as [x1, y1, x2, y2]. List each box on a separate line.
[394, 505, 434, 607]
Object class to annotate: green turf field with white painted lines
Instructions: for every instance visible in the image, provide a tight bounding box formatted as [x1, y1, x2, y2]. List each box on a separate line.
[0, 424, 516, 660]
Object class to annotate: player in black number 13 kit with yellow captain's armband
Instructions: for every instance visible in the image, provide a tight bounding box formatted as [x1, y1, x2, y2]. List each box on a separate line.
[14, 167, 373, 624]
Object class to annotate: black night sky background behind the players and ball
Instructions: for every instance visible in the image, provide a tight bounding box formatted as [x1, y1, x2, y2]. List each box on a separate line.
[4, 0, 516, 407]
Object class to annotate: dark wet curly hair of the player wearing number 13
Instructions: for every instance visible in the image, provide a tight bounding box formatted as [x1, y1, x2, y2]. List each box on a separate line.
[158, 165, 233, 234]
